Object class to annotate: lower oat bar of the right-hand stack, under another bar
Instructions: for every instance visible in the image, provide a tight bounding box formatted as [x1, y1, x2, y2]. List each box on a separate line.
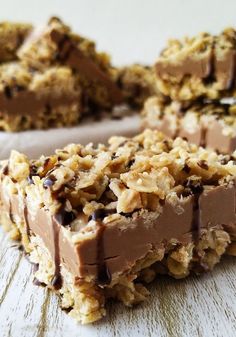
[142, 96, 236, 154]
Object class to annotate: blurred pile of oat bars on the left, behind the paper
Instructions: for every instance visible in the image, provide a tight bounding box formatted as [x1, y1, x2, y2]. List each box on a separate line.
[0, 17, 154, 131]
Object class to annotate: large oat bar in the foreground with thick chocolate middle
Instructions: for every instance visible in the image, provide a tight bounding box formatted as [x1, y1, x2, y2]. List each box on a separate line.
[0, 130, 236, 323]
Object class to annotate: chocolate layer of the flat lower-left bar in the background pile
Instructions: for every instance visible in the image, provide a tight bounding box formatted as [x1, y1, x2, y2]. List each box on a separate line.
[0, 90, 80, 116]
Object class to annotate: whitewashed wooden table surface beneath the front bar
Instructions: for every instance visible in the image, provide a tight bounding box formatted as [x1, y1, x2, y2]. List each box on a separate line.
[0, 229, 236, 337]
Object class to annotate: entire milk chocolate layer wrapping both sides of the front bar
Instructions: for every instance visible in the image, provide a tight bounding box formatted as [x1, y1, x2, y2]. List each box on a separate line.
[1, 183, 236, 288]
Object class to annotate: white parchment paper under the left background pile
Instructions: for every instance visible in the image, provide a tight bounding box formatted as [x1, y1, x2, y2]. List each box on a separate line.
[0, 115, 140, 159]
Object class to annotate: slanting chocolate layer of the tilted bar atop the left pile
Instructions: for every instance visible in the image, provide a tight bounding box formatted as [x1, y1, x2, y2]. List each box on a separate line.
[50, 29, 123, 104]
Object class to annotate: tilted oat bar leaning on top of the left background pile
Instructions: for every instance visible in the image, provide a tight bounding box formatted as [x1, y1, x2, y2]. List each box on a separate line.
[18, 17, 123, 109]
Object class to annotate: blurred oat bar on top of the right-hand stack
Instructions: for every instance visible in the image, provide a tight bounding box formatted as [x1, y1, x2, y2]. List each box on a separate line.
[155, 28, 236, 101]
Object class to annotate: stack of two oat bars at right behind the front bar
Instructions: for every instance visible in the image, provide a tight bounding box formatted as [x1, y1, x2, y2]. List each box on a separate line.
[143, 28, 236, 153]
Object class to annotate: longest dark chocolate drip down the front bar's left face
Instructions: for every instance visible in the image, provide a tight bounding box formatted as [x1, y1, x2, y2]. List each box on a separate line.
[51, 218, 62, 290]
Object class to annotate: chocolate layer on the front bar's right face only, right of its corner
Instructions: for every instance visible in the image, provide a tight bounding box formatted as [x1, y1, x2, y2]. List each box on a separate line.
[78, 182, 236, 275]
